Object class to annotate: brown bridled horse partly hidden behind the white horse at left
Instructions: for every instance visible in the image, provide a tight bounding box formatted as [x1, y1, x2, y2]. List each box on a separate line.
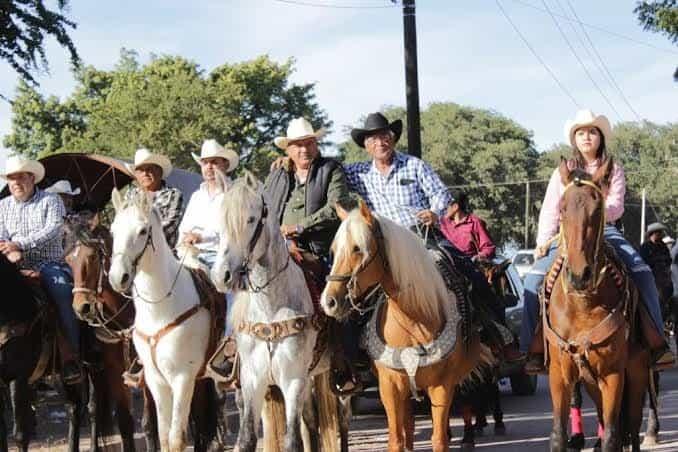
[66, 217, 225, 451]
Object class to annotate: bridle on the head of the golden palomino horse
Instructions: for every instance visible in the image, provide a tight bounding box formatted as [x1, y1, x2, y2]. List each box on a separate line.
[325, 219, 388, 315]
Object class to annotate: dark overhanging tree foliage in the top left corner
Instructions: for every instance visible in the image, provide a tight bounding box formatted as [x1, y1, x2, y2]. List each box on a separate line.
[0, 0, 80, 84]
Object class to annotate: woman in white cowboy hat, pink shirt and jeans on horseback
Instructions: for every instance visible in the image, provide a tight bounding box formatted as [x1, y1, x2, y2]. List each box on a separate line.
[520, 110, 674, 373]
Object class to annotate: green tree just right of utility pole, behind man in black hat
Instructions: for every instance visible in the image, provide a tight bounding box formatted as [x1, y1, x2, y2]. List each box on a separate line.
[339, 103, 538, 244]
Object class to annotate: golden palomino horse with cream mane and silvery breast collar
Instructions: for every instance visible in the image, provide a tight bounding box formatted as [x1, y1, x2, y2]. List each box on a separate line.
[321, 202, 491, 452]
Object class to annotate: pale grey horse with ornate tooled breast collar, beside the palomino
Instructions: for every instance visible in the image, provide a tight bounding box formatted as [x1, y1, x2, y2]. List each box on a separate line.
[212, 173, 337, 452]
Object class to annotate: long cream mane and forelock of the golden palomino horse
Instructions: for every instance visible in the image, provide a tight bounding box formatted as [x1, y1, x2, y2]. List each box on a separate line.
[337, 210, 452, 324]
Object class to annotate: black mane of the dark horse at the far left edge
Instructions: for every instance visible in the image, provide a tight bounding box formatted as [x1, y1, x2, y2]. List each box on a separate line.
[0, 253, 38, 325]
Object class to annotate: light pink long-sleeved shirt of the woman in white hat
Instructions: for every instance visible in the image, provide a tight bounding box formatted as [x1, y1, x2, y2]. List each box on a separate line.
[537, 160, 626, 246]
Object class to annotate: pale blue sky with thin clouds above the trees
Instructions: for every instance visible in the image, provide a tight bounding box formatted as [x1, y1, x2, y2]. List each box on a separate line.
[0, 0, 678, 170]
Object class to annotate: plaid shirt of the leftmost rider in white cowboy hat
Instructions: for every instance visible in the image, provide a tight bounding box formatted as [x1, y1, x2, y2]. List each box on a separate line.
[0, 187, 66, 270]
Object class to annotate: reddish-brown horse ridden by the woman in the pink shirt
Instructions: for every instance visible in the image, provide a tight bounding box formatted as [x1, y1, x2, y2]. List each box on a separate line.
[542, 160, 649, 451]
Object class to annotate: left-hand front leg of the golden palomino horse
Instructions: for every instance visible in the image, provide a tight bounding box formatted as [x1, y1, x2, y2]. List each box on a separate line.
[378, 369, 409, 452]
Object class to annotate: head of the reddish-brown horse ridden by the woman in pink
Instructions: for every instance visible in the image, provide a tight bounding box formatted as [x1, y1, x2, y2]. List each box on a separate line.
[559, 158, 612, 290]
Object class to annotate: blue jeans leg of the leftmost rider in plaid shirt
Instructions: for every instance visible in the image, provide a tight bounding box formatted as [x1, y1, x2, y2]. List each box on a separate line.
[38, 262, 80, 353]
